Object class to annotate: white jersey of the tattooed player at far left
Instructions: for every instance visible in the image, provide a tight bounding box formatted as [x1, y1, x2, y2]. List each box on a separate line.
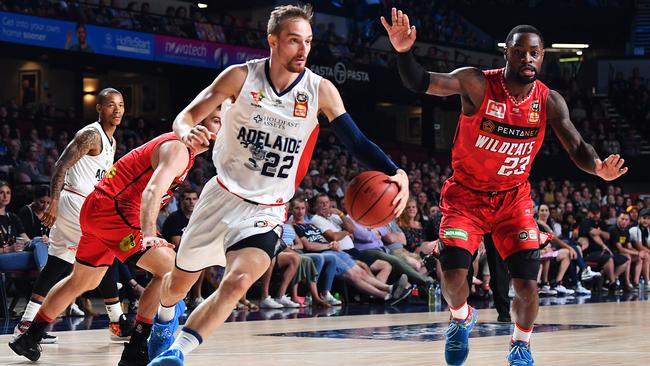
[64, 122, 116, 196]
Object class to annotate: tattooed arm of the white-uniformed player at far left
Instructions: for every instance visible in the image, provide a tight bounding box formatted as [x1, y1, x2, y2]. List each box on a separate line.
[41, 128, 102, 227]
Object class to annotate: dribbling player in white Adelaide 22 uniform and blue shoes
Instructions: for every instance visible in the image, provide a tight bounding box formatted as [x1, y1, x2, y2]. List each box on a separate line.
[149, 5, 408, 365]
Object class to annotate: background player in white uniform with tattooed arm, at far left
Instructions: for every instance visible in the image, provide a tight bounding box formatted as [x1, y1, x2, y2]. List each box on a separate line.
[14, 88, 130, 343]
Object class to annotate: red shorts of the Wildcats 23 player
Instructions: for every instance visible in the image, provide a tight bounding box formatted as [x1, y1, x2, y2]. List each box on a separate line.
[440, 178, 539, 259]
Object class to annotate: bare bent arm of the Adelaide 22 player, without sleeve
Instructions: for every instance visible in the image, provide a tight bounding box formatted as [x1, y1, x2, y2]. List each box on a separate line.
[174, 65, 248, 153]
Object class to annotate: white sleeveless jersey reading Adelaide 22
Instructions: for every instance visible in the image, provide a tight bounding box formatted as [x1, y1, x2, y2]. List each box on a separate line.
[213, 59, 321, 204]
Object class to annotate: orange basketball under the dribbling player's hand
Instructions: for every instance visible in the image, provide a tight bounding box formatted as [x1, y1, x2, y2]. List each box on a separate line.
[345, 171, 399, 228]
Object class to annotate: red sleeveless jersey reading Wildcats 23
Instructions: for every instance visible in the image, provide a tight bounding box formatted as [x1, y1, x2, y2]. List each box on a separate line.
[451, 69, 549, 192]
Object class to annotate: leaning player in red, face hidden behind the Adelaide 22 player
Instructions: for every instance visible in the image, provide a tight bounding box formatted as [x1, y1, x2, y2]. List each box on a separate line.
[9, 118, 220, 366]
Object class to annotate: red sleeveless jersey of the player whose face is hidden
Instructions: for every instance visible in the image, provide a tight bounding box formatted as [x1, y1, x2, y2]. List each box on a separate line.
[95, 132, 194, 227]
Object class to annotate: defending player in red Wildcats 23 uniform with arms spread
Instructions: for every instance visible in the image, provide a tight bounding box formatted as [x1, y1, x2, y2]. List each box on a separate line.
[381, 8, 627, 365]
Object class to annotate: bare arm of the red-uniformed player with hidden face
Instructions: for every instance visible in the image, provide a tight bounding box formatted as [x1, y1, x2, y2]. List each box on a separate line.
[140, 140, 190, 244]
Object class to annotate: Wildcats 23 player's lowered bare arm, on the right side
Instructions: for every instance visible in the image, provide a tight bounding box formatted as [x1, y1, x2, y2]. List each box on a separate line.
[546, 90, 627, 181]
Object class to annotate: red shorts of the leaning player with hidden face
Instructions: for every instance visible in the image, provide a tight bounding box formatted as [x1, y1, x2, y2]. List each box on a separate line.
[76, 190, 141, 267]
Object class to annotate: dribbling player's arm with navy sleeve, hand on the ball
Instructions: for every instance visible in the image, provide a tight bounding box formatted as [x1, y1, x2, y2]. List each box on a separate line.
[318, 79, 409, 216]
